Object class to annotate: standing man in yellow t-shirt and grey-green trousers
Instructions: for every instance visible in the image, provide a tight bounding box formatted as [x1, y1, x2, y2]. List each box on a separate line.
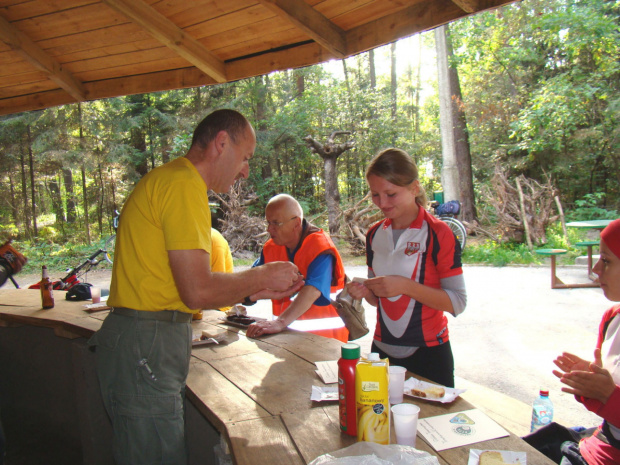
[89, 110, 303, 465]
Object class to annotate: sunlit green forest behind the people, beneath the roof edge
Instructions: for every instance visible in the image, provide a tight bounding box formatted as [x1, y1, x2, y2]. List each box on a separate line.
[0, 0, 620, 272]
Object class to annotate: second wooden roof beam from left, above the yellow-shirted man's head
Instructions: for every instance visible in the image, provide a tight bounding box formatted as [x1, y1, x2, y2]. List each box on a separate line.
[103, 0, 227, 82]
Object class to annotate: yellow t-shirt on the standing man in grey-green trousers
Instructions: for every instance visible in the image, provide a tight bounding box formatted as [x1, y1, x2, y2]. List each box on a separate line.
[108, 157, 211, 312]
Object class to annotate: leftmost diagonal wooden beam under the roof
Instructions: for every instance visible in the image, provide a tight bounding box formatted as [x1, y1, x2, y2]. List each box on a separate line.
[0, 16, 86, 102]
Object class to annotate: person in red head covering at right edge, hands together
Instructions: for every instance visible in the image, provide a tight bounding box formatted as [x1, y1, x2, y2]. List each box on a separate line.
[524, 219, 620, 465]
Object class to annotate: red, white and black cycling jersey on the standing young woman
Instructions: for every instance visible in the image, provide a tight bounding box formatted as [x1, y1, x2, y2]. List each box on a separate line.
[366, 208, 463, 347]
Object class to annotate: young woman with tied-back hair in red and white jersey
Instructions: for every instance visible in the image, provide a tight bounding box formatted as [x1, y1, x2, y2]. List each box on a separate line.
[347, 148, 467, 387]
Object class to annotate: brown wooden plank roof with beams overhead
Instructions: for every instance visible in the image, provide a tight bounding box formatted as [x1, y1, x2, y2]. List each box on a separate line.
[0, 0, 514, 114]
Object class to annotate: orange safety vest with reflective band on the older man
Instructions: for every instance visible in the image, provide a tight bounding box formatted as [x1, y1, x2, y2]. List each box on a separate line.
[263, 229, 349, 342]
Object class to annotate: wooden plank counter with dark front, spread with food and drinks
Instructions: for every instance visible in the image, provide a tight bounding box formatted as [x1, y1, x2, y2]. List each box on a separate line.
[0, 289, 553, 465]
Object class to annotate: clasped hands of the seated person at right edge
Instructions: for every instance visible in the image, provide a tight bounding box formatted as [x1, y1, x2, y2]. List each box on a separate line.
[553, 349, 616, 404]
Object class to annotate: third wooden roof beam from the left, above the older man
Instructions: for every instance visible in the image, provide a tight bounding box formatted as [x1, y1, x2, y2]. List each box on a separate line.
[254, 0, 347, 58]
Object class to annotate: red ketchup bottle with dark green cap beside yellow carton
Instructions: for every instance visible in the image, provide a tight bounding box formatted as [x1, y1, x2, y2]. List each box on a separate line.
[338, 343, 360, 436]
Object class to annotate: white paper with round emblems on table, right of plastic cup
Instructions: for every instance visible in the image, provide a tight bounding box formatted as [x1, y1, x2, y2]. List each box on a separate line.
[418, 409, 509, 451]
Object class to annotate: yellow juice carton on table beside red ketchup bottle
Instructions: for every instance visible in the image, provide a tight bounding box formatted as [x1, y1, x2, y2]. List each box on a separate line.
[355, 359, 390, 445]
